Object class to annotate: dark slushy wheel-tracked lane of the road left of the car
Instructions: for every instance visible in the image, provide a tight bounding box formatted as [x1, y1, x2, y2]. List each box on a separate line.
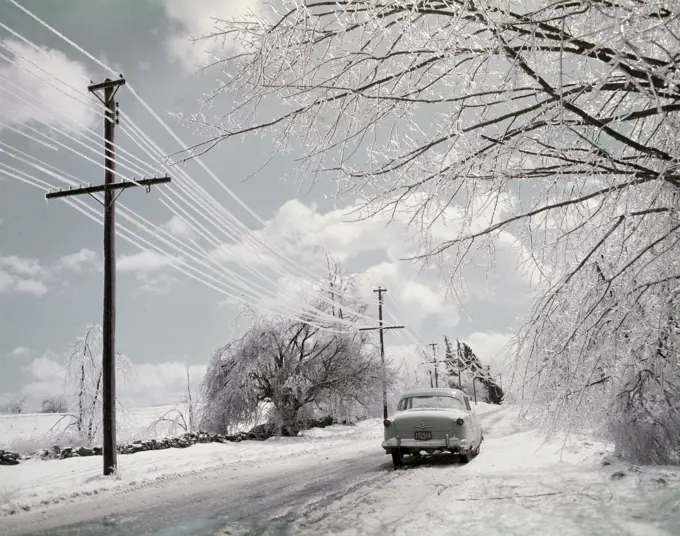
[0, 440, 468, 536]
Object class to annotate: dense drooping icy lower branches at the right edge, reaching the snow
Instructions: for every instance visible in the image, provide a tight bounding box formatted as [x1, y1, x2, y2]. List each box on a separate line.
[517, 187, 680, 463]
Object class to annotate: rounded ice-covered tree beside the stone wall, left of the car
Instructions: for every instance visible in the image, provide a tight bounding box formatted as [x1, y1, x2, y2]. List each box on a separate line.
[200, 262, 391, 435]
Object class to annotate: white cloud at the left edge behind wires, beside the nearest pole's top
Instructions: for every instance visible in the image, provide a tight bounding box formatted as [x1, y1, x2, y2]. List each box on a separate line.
[0, 39, 96, 132]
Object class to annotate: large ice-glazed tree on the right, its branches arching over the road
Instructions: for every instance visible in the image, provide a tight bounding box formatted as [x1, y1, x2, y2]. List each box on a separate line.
[185, 0, 680, 460]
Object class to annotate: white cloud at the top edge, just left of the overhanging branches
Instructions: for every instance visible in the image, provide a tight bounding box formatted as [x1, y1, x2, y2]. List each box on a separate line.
[161, 0, 263, 69]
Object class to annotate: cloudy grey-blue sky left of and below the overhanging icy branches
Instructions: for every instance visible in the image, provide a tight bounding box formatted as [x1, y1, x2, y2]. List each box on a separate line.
[0, 0, 530, 407]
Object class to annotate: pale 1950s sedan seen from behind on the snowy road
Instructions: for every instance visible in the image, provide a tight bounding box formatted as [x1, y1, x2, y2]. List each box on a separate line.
[382, 388, 484, 469]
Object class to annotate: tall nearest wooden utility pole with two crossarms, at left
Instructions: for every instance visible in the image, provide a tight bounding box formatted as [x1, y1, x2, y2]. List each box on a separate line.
[45, 75, 170, 475]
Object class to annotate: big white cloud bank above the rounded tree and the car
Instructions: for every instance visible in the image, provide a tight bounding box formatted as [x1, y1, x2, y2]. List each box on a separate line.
[211, 199, 532, 332]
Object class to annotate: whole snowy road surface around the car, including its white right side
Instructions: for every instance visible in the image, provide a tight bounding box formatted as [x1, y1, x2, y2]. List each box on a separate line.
[0, 410, 680, 536]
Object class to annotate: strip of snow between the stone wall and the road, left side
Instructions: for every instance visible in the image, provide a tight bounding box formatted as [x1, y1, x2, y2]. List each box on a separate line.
[0, 419, 383, 516]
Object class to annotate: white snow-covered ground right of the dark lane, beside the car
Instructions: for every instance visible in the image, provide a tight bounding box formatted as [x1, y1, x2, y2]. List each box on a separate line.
[270, 408, 680, 536]
